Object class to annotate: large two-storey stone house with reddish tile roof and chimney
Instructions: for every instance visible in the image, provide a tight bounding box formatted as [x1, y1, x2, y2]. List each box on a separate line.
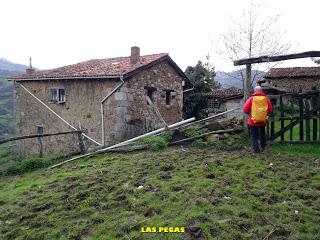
[10, 47, 192, 154]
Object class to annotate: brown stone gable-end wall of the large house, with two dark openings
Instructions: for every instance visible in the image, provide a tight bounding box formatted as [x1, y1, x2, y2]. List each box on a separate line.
[105, 62, 183, 145]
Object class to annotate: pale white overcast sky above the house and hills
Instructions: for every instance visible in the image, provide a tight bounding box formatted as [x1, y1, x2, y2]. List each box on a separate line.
[0, 0, 320, 71]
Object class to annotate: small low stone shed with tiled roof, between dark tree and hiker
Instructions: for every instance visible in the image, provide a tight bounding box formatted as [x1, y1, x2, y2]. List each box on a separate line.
[204, 87, 243, 119]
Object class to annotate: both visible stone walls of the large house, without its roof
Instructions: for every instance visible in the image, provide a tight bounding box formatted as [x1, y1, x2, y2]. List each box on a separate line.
[15, 54, 184, 154]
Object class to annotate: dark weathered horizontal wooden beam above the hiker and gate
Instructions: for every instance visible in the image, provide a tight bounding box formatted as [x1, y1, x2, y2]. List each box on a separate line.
[233, 51, 320, 66]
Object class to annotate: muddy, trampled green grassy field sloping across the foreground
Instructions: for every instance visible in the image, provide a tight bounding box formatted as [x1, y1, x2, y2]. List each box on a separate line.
[0, 143, 320, 240]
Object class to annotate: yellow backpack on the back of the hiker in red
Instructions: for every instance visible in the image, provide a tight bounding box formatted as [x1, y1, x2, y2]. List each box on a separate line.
[251, 96, 268, 123]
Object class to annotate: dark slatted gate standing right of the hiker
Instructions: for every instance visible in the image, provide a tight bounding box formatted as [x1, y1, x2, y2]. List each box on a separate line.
[266, 90, 320, 143]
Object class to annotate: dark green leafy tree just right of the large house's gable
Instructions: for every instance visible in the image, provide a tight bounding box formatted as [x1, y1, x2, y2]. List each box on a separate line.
[183, 58, 220, 119]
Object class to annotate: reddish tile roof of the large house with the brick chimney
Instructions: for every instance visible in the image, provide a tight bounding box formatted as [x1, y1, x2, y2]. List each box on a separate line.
[9, 53, 168, 80]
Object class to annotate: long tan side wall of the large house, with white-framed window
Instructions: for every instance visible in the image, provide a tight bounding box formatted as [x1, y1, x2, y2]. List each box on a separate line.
[15, 80, 118, 154]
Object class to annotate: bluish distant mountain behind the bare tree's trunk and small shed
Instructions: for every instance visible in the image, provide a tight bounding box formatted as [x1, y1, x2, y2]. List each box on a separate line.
[214, 69, 265, 89]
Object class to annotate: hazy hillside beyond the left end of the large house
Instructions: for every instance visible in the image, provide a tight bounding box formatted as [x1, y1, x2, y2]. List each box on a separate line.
[0, 58, 27, 138]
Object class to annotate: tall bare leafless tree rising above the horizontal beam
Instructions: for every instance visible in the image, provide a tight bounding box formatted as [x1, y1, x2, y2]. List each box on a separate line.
[217, 1, 291, 94]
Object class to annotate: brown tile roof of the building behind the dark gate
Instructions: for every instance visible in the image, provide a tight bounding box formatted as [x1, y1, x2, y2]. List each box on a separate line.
[264, 67, 320, 78]
